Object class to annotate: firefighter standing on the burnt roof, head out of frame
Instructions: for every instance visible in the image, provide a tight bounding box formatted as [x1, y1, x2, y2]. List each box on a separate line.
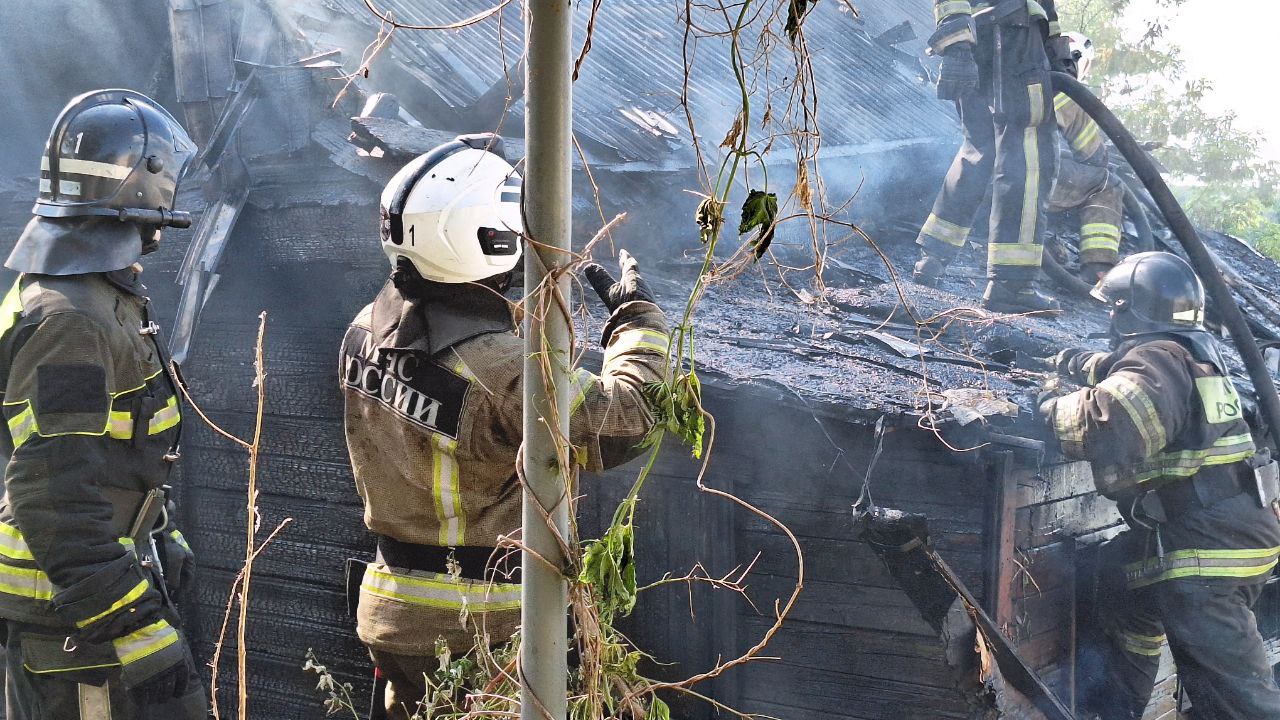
[913, 0, 1069, 313]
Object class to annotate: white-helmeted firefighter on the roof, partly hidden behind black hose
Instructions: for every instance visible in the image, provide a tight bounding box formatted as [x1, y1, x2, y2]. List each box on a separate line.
[1048, 32, 1124, 284]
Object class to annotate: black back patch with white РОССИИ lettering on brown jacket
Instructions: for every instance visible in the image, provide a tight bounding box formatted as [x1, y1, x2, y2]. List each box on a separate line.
[342, 328, 471, 439]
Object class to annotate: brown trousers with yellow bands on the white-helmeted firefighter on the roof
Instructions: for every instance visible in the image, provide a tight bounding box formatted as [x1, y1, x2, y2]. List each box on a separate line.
[1048, 151, 1124, 266]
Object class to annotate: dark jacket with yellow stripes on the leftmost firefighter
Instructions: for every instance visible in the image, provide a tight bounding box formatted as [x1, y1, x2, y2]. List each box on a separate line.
[0, 270, 189, 684]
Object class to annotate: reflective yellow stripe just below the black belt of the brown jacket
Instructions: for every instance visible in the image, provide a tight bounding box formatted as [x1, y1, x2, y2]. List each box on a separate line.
[360, 565, 520, 612]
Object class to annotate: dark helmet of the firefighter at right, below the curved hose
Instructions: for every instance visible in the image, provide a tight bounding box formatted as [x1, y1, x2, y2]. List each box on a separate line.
[1092, 252, 1204, 338]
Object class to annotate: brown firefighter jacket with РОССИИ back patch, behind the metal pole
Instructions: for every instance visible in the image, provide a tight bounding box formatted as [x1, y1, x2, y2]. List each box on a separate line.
[339, 283, 668, 655]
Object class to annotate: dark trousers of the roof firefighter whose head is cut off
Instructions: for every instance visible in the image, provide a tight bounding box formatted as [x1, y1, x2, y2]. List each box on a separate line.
[916, 23, 1057, 283]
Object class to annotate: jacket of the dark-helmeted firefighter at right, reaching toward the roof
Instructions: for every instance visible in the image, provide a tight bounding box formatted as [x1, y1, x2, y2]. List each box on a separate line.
[1041, 336, 1280, 588]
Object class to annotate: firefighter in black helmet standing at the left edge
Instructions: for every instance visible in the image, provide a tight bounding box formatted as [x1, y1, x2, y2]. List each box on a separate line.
[0, 90, 207, 720]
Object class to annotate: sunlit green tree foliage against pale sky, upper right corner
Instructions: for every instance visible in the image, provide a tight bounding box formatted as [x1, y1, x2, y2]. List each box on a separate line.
[1059, 0, 1280, 252]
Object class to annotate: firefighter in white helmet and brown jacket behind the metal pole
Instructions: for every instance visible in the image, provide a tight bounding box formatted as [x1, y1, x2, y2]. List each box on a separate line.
[339, 135, 668, 719]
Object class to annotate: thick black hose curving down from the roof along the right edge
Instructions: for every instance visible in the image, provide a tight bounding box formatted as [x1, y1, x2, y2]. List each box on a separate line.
[1052, 72, 1280, 448]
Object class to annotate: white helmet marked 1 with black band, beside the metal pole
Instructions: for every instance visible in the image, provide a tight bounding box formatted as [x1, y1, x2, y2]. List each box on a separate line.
[381, 133, 524, 283]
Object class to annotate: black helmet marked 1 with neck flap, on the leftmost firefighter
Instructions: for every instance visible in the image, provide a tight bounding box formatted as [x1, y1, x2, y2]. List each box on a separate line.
[5, 90, 196, 274]
